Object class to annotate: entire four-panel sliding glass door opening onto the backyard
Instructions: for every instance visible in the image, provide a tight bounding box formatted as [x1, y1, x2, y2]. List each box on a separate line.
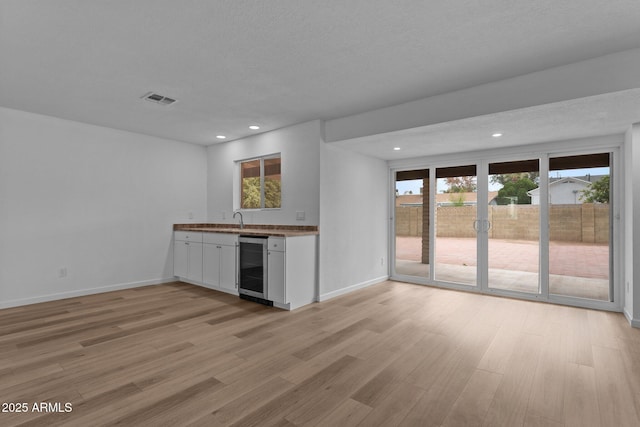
[392, 151, 616, 308]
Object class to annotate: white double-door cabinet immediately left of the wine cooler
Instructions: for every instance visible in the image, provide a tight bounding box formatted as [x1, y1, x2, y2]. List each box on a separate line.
[202, 233, 238, 294]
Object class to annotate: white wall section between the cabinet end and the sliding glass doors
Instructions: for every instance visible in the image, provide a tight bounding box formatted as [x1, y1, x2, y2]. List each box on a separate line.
[319, 144, 389, 300]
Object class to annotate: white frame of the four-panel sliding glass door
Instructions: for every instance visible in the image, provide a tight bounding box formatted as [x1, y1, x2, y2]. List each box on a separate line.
[389, 142, 624, 311]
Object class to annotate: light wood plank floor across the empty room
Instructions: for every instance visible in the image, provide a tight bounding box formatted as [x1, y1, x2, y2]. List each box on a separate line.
[0, 282, 640, 427]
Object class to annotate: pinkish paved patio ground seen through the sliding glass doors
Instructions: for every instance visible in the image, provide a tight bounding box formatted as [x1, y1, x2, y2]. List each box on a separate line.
[396, 236, 609, 301]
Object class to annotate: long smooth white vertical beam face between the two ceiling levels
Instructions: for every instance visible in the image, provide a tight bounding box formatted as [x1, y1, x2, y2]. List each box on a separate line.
[324, 49, 640, 142]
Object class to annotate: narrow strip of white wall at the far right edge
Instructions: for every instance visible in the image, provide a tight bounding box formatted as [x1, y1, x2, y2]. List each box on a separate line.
[624, 123, 640, 327]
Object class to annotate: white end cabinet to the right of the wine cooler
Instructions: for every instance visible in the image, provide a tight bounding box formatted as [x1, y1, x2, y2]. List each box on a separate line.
[267, 235, 317, 310]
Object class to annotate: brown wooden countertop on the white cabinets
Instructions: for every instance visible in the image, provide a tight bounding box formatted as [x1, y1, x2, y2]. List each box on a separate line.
[173, 224, 320, 237]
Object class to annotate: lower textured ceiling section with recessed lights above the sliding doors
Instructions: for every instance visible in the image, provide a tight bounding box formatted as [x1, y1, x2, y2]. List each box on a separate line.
[332, 89, 640, 160]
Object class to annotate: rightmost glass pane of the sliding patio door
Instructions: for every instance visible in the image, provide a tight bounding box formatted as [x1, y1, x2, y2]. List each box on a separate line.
[547, 153, 613, 301]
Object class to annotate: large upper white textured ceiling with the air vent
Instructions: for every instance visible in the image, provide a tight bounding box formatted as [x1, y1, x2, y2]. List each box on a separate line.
[0, 0, 640, 152]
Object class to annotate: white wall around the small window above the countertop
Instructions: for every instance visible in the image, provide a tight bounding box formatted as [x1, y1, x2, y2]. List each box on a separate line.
[207, 120, 321, 225]
